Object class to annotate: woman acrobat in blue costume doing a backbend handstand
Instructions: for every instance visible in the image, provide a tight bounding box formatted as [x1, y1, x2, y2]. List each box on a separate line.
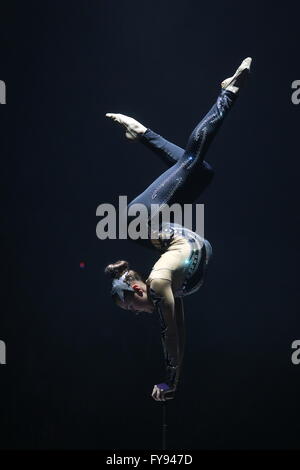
[105, 57, 252, 401]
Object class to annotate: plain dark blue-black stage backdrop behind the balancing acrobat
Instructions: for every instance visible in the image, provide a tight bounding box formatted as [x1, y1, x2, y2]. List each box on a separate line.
[0, 0, 300, 450]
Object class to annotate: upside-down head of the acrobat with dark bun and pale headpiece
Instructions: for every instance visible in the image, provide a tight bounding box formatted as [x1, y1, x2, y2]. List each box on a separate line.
[104, 260, 154, 313]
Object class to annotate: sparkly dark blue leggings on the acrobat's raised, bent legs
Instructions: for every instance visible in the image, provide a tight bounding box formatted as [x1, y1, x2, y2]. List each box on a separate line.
[127, 90, 237, 222]
